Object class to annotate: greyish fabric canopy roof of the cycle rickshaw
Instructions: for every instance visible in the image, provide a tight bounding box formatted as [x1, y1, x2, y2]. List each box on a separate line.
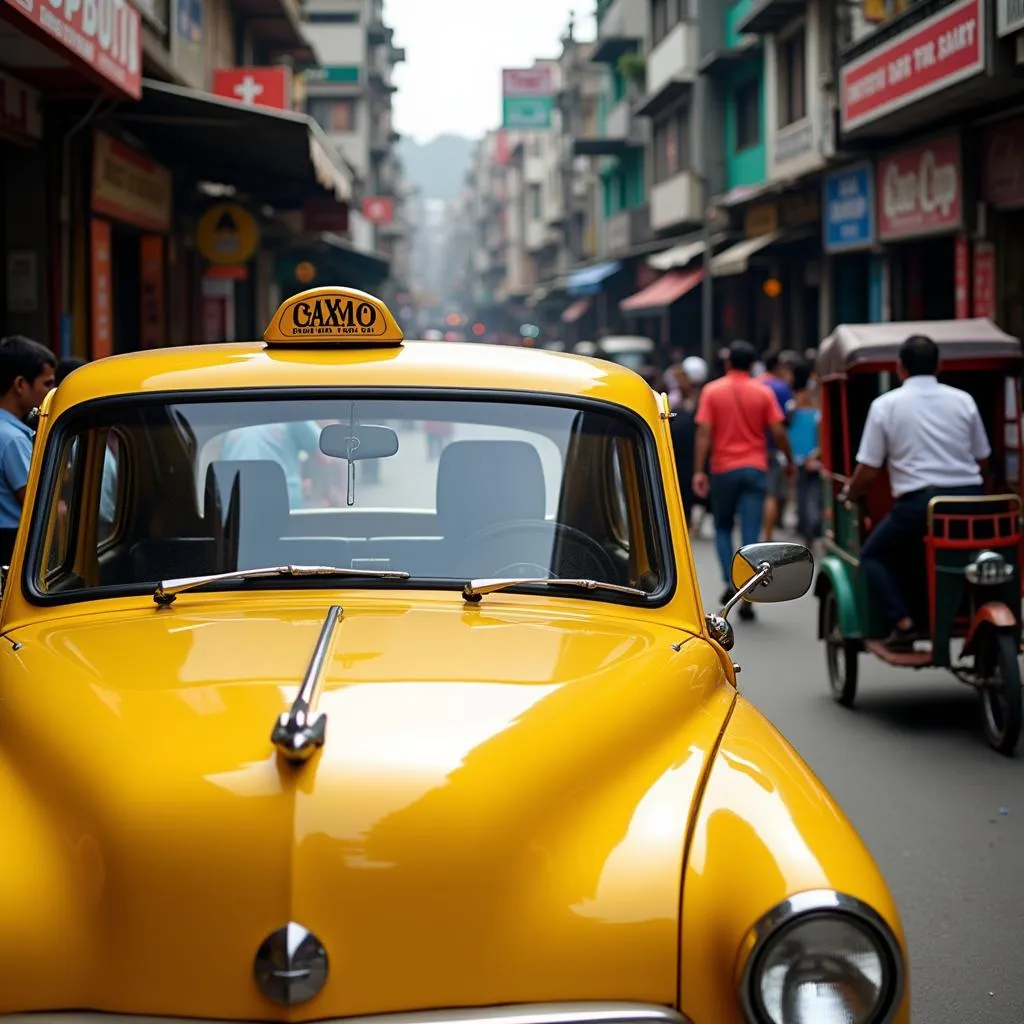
[816, 316, 1021, 378]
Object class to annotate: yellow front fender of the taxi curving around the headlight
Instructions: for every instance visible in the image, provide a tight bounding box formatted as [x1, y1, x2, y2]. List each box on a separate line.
[680, 697, 910, 1024]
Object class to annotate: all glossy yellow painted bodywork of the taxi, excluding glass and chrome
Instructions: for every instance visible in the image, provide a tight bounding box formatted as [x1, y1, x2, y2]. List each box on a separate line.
[0, 331, 908, 1024]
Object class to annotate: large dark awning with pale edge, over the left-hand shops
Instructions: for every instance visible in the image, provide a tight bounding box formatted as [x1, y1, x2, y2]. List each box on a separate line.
[115, 79, 352, 209]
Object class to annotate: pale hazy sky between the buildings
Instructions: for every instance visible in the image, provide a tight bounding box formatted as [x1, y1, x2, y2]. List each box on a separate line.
[384, 0, 594, 142]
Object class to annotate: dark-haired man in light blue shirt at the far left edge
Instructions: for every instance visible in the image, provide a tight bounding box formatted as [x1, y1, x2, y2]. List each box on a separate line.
[0, 335, 57, 565]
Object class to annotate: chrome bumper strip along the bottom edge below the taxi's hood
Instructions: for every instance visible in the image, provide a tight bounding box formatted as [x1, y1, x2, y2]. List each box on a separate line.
[0, 1002, 692, 1024]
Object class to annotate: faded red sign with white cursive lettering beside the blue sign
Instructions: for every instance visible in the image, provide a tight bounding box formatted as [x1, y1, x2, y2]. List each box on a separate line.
[876, 133, 964, 242]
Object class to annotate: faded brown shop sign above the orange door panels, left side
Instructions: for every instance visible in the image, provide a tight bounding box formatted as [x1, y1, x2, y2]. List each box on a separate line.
[92, 131, 172, 231]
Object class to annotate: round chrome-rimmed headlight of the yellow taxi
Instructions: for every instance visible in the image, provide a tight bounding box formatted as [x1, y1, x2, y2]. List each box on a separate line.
[740, 890, 903, 1024]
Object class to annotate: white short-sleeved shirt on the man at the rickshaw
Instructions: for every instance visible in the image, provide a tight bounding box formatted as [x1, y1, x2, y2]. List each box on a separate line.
[857, 376, 992, 498]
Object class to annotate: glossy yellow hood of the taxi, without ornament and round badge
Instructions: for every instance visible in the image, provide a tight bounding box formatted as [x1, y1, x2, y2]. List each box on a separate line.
[0, 593, 734, 1020]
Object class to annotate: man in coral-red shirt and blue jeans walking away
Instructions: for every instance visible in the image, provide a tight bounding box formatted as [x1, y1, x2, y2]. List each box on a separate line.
[693, 341, 795, 620]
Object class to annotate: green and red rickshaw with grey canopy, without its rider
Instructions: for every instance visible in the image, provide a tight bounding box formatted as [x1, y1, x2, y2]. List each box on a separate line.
[814, 318, 1024, 755]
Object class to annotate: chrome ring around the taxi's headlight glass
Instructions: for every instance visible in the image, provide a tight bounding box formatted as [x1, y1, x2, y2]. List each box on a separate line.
[737, 889, 906, 1024]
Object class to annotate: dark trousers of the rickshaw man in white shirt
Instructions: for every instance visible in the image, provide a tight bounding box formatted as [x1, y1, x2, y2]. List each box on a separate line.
[860, 485, 985, 626]
